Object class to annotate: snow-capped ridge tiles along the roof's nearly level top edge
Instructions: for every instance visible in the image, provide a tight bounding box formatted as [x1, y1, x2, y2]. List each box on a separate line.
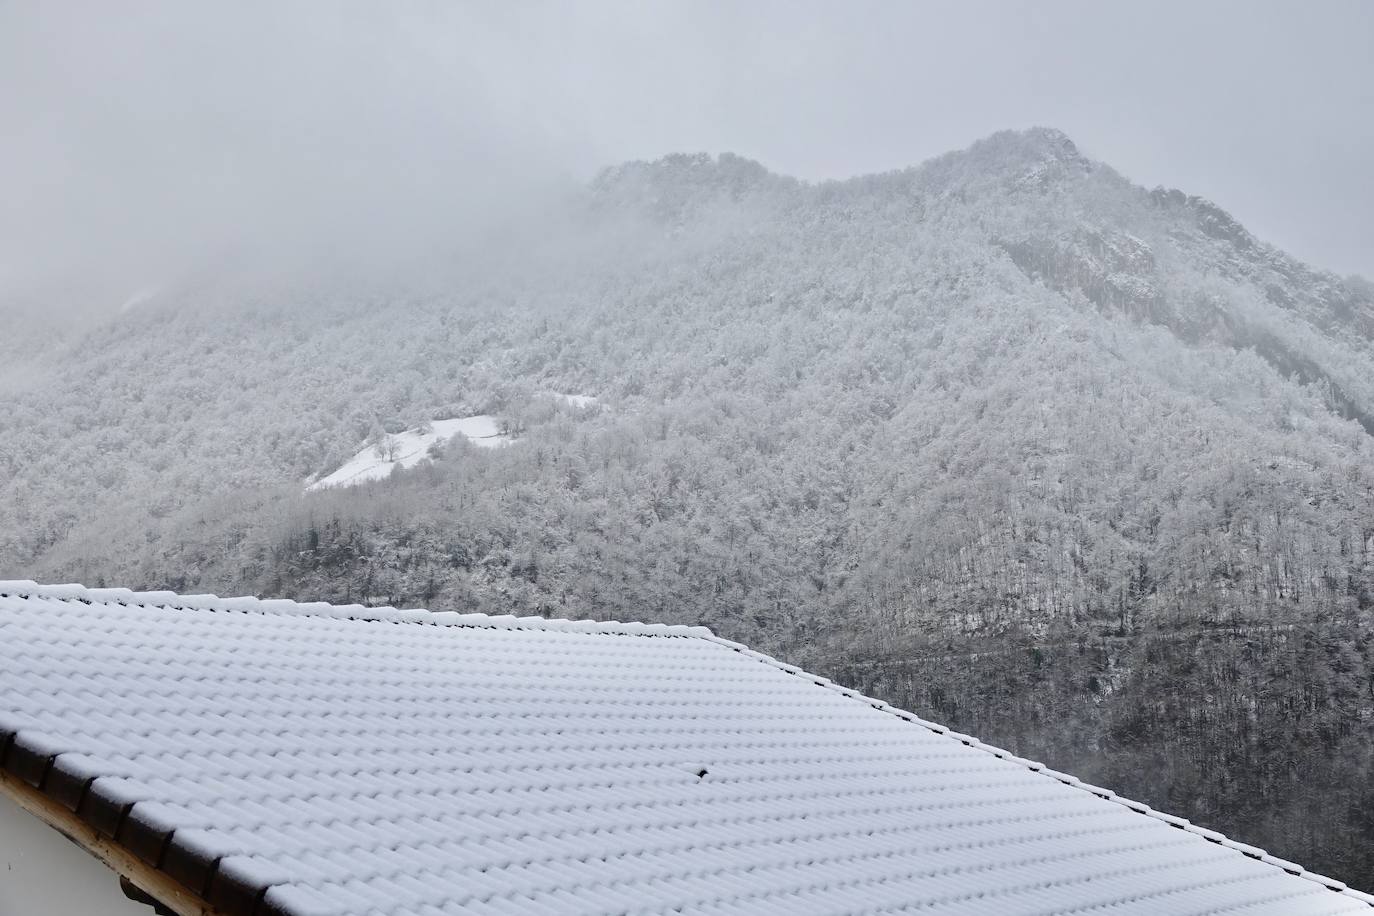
[0, 580, 713, 639]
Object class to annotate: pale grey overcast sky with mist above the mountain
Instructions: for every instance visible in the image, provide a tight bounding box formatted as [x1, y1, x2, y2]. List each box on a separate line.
[0, 0, 1374, 304]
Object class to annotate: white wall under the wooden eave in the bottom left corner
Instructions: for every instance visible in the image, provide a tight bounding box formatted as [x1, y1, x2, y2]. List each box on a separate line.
[0, 795, 153, 916]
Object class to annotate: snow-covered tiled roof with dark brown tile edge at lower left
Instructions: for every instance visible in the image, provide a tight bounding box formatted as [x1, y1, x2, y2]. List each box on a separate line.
[0, 582, 1374, 916]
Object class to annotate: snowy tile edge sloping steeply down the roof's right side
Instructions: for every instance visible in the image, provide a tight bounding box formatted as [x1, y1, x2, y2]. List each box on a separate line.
[703, 633, 1374, 908]
